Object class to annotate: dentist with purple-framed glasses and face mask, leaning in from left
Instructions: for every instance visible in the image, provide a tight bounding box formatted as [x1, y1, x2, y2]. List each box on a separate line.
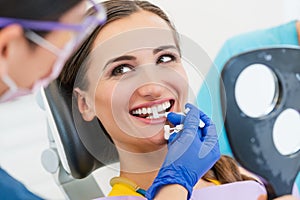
[0, 0, 105, 199]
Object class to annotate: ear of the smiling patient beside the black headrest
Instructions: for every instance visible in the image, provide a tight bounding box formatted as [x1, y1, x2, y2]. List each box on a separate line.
[74, 88, 96, 121]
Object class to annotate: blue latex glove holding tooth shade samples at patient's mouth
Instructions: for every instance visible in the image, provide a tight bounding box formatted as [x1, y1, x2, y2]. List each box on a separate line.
[146, 104, 220, 199]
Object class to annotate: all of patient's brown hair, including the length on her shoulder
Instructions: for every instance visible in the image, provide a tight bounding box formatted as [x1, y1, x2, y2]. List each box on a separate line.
[58, 0, 253, 186]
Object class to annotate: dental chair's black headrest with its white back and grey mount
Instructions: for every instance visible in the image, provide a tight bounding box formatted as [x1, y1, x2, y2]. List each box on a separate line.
[37, 81, 118, 200]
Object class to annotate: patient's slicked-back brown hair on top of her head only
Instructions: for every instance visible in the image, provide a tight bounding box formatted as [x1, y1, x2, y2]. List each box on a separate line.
[58, 0, 179, 94]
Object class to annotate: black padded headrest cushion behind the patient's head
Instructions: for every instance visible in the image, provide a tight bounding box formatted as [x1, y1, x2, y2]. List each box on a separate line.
[44, 80, 118, 179]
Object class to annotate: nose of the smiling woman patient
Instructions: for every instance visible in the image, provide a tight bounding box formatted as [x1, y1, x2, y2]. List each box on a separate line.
[137, 83, 164, 100]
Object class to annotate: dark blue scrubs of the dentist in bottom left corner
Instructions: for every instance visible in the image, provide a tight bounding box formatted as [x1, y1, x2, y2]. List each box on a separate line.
[0, 167, 41, 200]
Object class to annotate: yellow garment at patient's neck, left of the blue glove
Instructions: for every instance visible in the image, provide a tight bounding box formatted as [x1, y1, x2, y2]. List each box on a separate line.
[108, 177, 143, 197]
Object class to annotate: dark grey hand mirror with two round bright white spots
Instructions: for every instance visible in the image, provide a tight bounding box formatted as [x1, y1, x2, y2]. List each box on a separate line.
[221, 47, 300, 199]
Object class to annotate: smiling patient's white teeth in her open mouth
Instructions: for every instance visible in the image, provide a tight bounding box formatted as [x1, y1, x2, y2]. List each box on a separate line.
[132, 101, 171, 119]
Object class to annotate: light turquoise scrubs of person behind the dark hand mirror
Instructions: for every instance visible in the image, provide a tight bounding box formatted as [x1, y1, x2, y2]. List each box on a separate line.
[197, 21, 300, 189]
